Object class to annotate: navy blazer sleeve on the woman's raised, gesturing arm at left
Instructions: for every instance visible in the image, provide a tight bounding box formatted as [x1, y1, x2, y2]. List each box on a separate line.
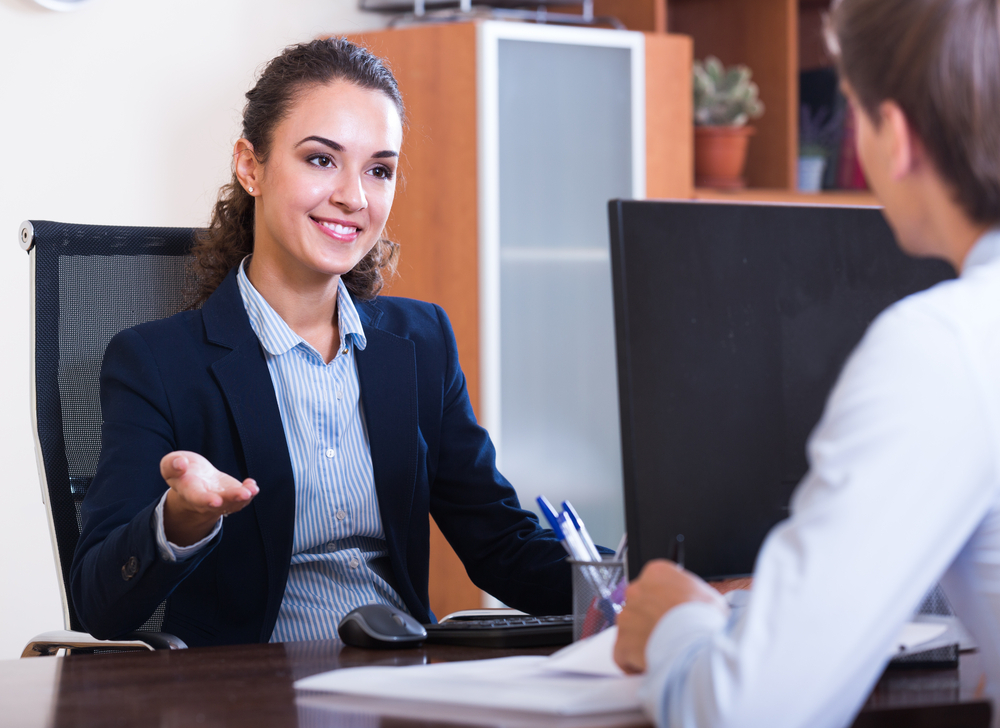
[70, 329, 221, 639]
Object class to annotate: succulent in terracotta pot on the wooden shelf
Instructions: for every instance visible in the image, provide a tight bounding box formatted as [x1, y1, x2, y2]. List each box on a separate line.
[694, 56, 764, 189]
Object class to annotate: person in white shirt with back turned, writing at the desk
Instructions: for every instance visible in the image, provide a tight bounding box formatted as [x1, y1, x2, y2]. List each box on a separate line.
[615, 0, 1000, 728]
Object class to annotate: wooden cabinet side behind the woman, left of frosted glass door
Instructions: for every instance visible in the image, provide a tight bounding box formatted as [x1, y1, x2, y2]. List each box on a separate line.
[351, 23, 482, 617]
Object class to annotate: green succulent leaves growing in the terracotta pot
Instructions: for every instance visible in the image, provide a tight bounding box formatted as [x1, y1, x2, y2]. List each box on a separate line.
[694, 56, 764, 126]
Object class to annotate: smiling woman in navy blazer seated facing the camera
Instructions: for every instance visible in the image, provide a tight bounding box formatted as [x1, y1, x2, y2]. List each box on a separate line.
[71, 39, 571, 645]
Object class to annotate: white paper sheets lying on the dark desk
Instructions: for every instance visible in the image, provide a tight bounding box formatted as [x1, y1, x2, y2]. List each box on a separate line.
[295, 628, 642, 716]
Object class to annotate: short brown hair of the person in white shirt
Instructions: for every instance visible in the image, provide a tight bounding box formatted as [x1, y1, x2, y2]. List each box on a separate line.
[827, 0, 1000, 224]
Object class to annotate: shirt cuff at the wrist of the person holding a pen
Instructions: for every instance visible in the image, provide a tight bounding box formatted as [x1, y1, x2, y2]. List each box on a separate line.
[639, 602, 729, 726]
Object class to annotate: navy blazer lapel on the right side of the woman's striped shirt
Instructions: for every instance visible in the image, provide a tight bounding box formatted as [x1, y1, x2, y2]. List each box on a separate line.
[357, 306, 418, 586]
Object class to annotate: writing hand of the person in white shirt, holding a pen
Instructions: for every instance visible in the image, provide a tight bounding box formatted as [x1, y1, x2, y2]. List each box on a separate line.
[615, 559, 728, 673]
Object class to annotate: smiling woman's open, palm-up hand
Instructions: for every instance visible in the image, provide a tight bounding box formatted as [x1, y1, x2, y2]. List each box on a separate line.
[160, 450, 260, 546]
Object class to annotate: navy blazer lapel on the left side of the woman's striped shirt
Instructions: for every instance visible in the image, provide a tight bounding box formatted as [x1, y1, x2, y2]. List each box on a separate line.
[203, 272, 295, 641]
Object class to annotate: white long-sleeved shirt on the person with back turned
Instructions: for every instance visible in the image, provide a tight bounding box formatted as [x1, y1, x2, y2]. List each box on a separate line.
[642, 230, 1000, 728]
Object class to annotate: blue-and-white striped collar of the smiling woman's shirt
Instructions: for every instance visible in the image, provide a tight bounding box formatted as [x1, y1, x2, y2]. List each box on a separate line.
[236, 256, 368, 356]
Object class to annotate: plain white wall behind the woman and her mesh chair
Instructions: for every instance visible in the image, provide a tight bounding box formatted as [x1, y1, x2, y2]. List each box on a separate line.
[0, 0, 384, 659]
